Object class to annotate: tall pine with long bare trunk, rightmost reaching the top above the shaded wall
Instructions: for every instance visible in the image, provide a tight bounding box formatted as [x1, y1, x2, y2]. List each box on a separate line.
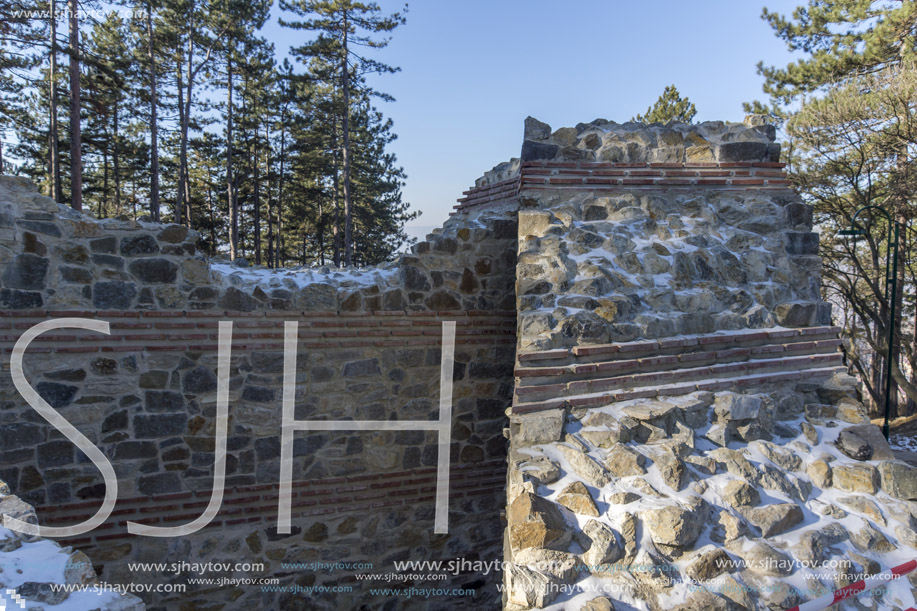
[280, 0, 407, 265]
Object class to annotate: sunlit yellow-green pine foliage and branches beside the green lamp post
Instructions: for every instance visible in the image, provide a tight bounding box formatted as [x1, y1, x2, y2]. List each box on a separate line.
[745, 0, 917, 414]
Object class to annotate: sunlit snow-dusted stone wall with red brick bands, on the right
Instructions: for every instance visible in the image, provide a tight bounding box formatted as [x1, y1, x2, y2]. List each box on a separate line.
[500, 119, 917, 611]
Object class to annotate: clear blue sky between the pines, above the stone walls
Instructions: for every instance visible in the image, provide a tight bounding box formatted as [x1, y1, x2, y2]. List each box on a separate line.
[265, 0, 802, 237]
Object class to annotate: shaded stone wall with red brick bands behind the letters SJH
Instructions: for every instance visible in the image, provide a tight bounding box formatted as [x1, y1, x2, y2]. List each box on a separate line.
[0, 177, 516, 608]
